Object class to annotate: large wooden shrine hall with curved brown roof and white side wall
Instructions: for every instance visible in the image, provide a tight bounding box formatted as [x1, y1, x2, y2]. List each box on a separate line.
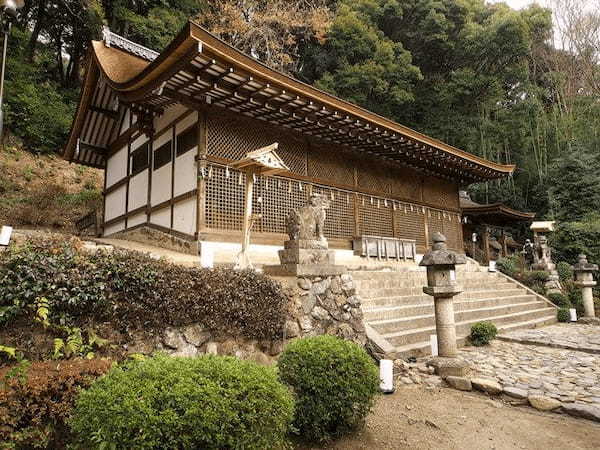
[64, 22, 514, 262]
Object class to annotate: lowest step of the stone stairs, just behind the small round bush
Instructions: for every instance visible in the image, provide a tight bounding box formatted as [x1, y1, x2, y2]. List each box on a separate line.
[384, 307, 556, 347]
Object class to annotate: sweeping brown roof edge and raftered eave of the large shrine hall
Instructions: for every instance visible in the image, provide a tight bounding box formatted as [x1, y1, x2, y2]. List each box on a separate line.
[64, 22, 515, 183]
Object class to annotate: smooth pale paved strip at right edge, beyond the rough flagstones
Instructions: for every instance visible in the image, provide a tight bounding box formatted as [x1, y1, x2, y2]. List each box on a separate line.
[498, 323, 600, 354]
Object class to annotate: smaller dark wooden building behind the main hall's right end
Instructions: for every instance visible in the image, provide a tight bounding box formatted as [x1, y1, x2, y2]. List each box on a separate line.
[459, 191, 535, 264]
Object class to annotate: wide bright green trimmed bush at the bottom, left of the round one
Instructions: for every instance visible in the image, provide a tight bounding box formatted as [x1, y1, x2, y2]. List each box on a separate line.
[71, 355, 294, 449]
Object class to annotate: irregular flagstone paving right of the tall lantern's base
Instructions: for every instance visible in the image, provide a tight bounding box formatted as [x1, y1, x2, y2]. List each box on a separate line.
[460, 338, 600, 407]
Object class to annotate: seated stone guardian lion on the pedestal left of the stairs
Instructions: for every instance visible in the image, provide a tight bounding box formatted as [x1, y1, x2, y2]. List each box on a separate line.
[285, 194, 329, 244]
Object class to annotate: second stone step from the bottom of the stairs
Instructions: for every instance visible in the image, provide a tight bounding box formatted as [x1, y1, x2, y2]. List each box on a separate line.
[369, 301, 546, 335]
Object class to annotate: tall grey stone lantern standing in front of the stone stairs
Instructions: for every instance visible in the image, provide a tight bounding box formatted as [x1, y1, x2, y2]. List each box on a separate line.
[420, 232, 468, 377]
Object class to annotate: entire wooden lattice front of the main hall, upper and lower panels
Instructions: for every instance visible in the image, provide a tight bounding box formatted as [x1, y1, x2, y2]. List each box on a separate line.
[205, 111, 462, 249]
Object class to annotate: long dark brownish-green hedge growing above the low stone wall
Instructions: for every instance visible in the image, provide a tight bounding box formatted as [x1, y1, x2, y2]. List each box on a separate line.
[0, 235, 288, 340]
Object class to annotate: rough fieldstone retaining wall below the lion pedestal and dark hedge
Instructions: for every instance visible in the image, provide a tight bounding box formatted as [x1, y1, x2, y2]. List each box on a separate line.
[126, 274, 367, 364]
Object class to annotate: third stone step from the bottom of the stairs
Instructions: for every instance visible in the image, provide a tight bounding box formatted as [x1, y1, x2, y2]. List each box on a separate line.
[363, 295, 545, 323]
